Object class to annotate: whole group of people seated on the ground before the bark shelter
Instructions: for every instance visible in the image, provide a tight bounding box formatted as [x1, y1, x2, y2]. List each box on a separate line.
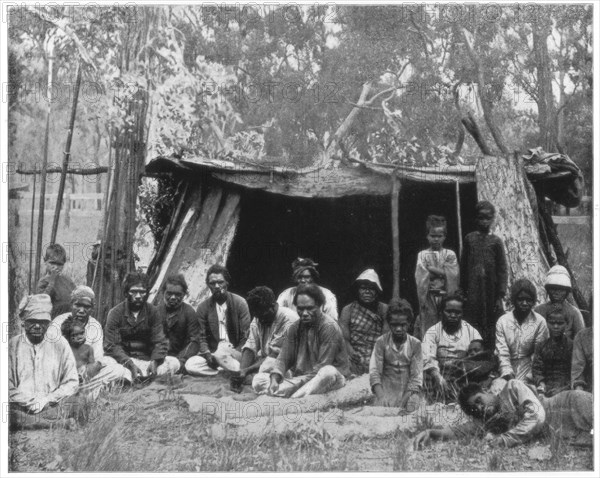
[9, 241, 593, 446]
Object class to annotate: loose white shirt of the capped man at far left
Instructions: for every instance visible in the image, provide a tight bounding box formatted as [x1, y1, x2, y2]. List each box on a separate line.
[8, 332, 79, 412]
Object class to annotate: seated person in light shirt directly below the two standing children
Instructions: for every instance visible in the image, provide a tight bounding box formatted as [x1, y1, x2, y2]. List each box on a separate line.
[423, 294, 481, 398]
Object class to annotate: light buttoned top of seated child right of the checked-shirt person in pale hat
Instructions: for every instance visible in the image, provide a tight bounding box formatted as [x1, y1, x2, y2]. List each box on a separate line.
[369, 332, 423, 398]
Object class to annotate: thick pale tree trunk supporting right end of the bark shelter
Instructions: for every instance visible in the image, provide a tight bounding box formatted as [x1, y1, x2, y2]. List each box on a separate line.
[475, 156, 548, 301]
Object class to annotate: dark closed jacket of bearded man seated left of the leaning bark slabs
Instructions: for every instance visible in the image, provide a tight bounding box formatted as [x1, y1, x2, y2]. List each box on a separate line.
[104, 300, 169, 364]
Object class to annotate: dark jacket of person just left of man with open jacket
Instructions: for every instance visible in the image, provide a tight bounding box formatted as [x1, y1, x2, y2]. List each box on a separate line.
[158, 302, 200, 365]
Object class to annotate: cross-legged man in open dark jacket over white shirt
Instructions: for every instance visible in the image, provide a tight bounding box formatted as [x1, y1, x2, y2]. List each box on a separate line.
[186, 264, 251, 375]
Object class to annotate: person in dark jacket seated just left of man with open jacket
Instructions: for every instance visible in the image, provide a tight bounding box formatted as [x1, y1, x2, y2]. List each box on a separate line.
[158, 274, 200, 372]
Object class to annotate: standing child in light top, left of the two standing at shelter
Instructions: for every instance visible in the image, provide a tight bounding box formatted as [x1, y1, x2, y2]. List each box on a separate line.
[414, 216, 458, 340]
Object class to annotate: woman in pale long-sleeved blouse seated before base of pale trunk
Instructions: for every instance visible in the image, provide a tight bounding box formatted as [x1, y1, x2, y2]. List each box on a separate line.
[496, 279, 548, 383]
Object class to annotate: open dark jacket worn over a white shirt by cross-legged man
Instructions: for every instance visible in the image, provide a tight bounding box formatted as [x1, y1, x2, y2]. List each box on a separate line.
[196, 292, 252, 355]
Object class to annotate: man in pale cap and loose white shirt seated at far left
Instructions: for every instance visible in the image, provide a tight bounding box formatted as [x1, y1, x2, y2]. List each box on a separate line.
[8, 294, 79, 428]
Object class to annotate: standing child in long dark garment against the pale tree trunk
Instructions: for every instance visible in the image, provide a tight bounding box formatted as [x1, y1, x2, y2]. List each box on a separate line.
[460, 201, 508, 349]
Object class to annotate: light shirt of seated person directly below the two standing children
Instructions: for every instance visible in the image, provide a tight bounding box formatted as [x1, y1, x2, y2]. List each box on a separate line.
[423, 320, 481, 372]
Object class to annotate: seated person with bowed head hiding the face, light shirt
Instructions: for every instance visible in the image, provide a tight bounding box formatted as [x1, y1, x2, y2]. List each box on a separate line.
[232, 286, 298, 394]
